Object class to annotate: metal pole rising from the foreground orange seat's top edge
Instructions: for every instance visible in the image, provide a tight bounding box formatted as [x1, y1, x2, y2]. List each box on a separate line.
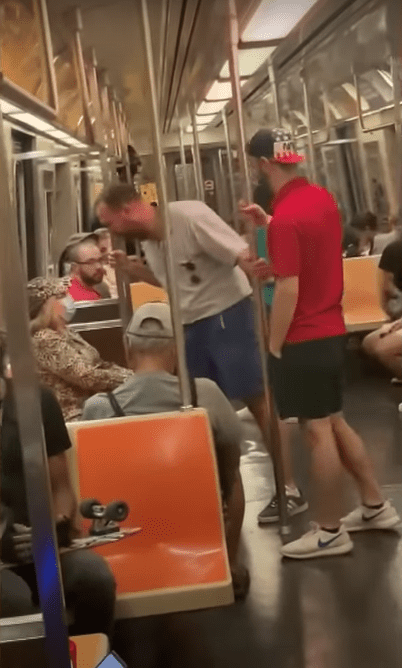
[141, 0, 192, 408]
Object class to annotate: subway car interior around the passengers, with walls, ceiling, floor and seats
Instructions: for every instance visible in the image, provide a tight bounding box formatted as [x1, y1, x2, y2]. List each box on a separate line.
[0, 0, 402, 668]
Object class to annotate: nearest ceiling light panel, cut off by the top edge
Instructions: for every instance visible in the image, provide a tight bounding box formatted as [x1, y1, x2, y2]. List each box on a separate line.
[241, 0, 316, 42]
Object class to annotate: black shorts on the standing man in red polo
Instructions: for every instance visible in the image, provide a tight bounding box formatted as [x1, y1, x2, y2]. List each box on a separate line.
[269, 336, 345, 420]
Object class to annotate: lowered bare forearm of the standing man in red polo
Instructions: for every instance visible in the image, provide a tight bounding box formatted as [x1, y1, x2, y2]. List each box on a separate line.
[269, 276, 299, 357]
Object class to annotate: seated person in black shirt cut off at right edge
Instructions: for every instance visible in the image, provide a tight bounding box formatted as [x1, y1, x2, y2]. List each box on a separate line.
[363, 239, 402, 383]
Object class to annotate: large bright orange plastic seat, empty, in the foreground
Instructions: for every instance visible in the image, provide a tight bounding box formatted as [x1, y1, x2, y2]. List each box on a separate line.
[69, 409, 233, 618]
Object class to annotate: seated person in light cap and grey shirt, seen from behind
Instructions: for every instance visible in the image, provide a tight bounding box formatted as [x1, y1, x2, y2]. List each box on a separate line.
[82, 303, 249, 596]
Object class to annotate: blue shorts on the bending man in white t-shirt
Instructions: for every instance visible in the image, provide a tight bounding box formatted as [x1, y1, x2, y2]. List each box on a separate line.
[185, 298, 264, 400]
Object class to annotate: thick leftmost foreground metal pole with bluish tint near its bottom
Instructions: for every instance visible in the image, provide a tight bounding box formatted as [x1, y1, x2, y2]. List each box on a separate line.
[0, 110, 70, 668]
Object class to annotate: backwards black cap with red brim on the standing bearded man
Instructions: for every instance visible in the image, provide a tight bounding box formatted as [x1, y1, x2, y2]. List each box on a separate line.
[247, 128, 304, 165]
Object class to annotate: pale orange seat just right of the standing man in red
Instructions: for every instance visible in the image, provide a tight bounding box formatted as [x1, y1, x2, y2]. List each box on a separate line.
[343, 256, 387, 332]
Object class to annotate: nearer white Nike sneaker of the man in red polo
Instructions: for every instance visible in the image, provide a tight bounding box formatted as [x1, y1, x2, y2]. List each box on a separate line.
[281, 525, 353, 559]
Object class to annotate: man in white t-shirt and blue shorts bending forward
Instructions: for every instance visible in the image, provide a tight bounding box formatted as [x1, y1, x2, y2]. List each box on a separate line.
[97, 184, 307, 523]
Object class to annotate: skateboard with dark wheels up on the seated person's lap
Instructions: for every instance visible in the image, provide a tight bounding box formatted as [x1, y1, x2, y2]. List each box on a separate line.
[0, 499, 141, 570]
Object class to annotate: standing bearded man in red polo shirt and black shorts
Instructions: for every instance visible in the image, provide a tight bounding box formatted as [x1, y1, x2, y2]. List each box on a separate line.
[244, 129, 400, 559]
